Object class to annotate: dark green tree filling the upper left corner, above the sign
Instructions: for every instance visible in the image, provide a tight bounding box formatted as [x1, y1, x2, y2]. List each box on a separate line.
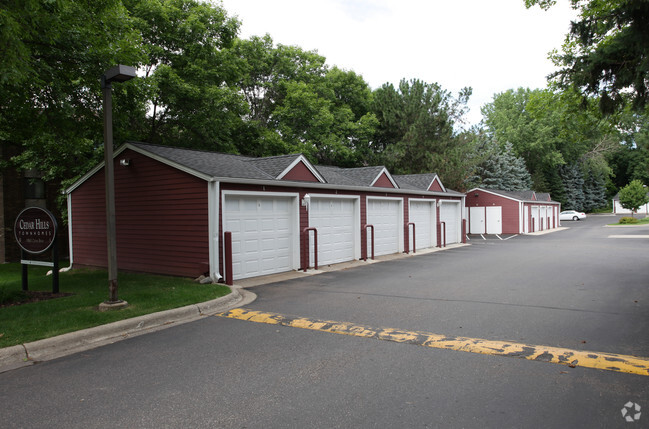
[0, 0, 143, 181]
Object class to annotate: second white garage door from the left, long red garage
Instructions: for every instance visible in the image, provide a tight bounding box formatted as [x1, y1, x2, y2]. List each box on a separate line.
[309, 196, 360, 265]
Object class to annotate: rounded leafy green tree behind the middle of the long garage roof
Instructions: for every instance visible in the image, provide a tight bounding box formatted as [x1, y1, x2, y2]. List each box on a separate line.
[228, 35, 377, 166]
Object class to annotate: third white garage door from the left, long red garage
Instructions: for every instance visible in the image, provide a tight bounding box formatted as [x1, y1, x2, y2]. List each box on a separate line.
[367, 198, 403, 256]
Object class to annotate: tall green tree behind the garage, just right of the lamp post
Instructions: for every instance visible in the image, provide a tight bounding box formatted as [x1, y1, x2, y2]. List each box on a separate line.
[124, 0, 246, 152]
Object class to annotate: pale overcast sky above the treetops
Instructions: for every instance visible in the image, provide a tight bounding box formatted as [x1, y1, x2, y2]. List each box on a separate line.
[221, 0, 576, 125]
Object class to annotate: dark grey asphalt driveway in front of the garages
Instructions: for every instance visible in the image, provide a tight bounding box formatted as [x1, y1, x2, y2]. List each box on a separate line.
[0, 212, 649, 428]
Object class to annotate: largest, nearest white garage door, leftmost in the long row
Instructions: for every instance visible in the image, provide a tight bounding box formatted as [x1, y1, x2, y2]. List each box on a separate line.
[223, 195, 298, 279]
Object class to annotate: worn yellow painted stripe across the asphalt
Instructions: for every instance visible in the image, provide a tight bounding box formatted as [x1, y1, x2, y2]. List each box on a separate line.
[216, 308, 649, 376]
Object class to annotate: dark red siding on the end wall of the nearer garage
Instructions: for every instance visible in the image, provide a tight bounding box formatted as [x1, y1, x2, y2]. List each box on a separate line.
[72, 150, 209, 277]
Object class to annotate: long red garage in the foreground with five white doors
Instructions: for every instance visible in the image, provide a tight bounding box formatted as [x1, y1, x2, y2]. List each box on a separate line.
[66, 142, 465, 279]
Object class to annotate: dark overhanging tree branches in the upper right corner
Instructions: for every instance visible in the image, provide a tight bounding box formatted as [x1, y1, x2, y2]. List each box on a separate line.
[525, 0, 649, 113]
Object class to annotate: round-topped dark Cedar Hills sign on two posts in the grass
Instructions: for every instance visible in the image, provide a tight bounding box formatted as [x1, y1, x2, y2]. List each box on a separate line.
[14, 207, 59, 293]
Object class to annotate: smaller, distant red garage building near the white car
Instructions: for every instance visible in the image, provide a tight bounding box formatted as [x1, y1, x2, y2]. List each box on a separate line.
[465, 188, 561, 234]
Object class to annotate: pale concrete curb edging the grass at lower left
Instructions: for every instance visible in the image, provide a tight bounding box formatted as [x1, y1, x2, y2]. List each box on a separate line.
[0, 286, 257, 373]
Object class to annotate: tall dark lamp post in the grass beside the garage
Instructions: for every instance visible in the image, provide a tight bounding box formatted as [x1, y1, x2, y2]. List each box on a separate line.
[99, 65, 135, 310]
